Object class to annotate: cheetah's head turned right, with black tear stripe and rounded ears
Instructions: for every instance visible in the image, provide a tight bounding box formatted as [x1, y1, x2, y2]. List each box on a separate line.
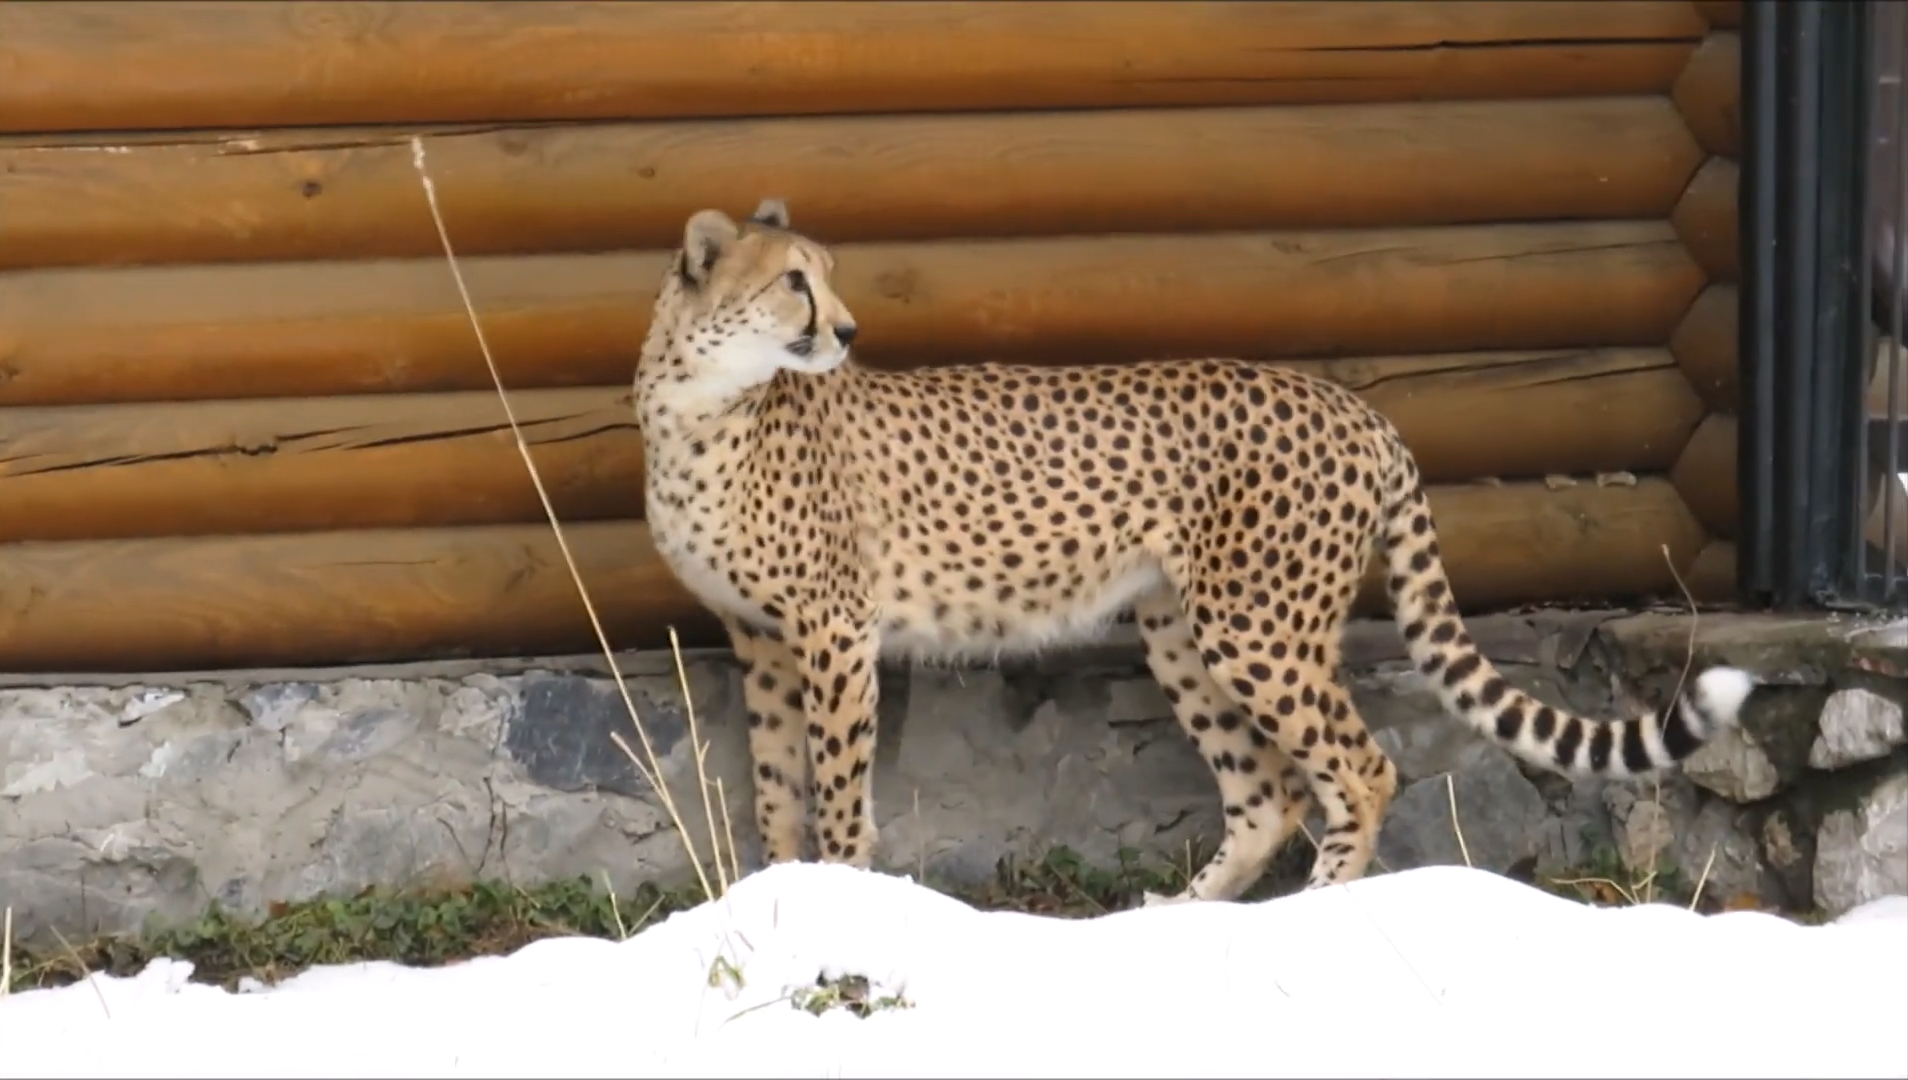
[656, 198, 855, 387]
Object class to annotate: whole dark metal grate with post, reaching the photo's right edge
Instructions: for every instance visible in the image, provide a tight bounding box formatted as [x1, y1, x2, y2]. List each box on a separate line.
[1738, 0, 1908, 609]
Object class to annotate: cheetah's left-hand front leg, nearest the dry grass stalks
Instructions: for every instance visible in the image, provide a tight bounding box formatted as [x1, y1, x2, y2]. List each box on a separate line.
[723, 620, 809, 862]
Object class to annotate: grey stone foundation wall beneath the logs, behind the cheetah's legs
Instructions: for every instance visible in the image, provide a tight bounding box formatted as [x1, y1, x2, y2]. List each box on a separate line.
[0, 613, 1908, 941]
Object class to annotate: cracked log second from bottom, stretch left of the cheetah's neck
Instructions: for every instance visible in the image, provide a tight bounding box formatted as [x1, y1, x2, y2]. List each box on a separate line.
[0, 387, 643, 542]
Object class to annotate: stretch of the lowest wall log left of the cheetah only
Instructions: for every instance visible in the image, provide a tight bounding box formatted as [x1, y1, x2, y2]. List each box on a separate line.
[0, 523, 712, 672]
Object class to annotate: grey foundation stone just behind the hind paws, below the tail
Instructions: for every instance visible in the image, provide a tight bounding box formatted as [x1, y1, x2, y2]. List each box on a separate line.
[1378, 750, 1551, 874]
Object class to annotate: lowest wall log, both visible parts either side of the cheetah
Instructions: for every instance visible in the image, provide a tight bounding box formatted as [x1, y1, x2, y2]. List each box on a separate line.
[0, 479, 1704, 672]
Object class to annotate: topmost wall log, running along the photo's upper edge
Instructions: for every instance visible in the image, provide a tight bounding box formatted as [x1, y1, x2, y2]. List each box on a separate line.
[0, 0, 1708, 132]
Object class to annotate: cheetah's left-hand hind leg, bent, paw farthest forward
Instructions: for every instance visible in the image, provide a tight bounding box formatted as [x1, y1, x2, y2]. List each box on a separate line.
[1133, 588, 1311, 906]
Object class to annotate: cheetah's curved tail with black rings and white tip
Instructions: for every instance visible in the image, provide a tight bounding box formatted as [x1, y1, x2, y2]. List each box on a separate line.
[1383, 473, 1755, 777]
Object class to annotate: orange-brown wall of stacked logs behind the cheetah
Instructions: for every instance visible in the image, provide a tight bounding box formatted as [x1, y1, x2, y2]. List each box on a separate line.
[0, 0, 1740, 670]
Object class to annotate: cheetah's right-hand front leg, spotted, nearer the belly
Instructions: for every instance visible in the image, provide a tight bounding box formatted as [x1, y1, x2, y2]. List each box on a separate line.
[796, 618, 880, 868]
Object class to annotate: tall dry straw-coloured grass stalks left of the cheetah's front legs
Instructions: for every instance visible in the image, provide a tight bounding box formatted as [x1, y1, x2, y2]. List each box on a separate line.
[410, 135, 735, 901]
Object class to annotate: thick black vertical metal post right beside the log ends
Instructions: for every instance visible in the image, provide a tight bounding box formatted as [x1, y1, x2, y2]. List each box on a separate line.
[1738, 0, 1876, 609]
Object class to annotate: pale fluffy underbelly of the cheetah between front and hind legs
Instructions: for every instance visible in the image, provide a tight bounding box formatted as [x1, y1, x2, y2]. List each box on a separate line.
[880, 553, 1166, 662]
